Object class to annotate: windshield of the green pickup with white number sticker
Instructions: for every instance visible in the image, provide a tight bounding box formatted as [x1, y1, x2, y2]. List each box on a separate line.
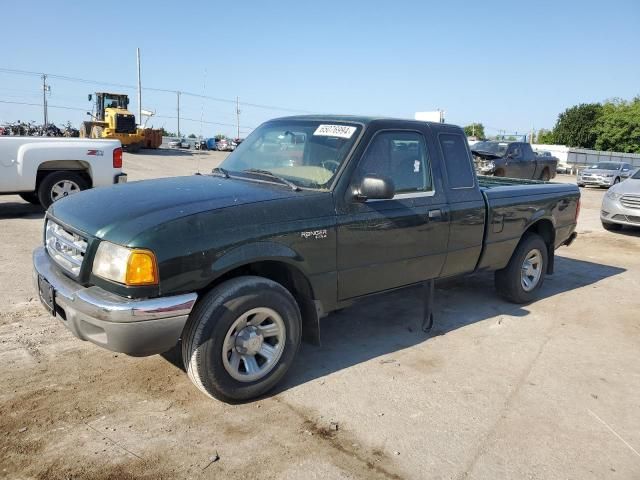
[220, 120, 361, 189]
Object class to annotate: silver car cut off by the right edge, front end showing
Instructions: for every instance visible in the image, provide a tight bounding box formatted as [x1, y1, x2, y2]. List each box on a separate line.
[600, 170, 640, 230]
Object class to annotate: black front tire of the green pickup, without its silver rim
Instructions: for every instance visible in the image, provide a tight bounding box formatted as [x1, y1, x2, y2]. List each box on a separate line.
[182, 276, 302, 403]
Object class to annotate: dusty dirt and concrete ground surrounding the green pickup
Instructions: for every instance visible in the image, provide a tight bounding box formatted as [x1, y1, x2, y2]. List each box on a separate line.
[0, 152, 640, 480]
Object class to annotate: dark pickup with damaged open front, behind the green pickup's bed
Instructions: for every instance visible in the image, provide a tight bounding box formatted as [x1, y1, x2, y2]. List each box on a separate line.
[471, 140, 558, 181]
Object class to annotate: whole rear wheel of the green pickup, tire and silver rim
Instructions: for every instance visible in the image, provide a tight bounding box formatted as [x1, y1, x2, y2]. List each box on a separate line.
[495, 233, 548, 303]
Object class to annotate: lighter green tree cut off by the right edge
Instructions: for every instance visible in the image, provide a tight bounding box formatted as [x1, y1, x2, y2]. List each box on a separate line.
[593, 97, 640, 153]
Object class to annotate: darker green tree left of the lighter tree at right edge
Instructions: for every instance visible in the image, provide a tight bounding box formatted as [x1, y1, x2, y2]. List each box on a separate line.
[553, 103, 603, 148]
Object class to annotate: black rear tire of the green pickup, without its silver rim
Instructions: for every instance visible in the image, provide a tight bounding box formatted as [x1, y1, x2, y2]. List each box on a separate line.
[495, 233, 548, 303]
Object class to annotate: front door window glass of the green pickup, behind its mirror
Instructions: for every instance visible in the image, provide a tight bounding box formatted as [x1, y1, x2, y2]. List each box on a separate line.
[358, 132, 433, 194]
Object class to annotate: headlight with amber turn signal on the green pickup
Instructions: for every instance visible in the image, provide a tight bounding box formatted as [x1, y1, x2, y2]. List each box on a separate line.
[93, 242, 158, 285]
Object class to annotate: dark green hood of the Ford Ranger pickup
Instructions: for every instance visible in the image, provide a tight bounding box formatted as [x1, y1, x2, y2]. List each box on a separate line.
[48, 175, 305, 245]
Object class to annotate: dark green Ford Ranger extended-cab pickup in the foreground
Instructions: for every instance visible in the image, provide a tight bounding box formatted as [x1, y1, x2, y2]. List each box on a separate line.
[33, 116, 580, 401]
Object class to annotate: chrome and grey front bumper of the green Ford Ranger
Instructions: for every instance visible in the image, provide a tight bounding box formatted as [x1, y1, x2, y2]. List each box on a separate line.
[33, 247, 198, 356]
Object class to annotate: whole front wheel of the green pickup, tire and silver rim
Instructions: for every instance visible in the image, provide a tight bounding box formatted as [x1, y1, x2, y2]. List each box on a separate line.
[182, 276, 302, 402]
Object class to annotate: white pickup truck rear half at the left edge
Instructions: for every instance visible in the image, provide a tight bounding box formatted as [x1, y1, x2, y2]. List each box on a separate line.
[0, 137, 127, 208]
